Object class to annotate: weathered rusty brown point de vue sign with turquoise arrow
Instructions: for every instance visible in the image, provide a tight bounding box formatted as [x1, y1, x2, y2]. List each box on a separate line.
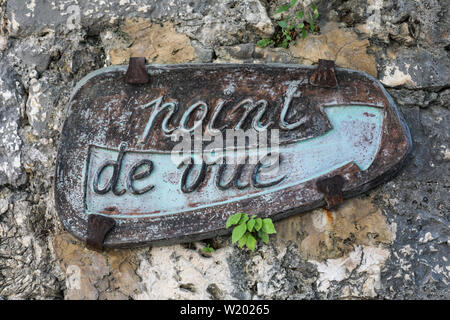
[55, 59, 411, 249]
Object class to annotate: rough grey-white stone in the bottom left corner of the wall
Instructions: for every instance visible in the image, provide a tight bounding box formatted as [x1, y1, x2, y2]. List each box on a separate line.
[0, 189, 62, 299]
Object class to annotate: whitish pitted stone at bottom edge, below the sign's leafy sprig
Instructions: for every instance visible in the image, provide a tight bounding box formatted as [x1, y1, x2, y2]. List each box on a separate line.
[136, 245, 235, 299]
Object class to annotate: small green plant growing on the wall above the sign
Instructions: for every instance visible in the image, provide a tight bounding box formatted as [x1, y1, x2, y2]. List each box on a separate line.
[257, 0, 319, 48]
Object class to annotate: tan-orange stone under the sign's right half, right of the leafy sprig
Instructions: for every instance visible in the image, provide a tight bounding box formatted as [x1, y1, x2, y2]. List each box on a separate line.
[277, 198, 396, 261]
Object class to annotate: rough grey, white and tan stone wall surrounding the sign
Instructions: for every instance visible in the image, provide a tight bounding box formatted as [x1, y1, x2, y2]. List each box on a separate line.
[0, 0, 450, 299]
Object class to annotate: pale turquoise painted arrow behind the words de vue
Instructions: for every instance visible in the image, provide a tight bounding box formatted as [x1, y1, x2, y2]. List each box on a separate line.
[86, 106, 383, 217]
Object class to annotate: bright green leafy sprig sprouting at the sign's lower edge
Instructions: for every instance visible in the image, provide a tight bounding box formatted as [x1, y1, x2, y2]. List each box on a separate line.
[225, 213, 277, 251]
